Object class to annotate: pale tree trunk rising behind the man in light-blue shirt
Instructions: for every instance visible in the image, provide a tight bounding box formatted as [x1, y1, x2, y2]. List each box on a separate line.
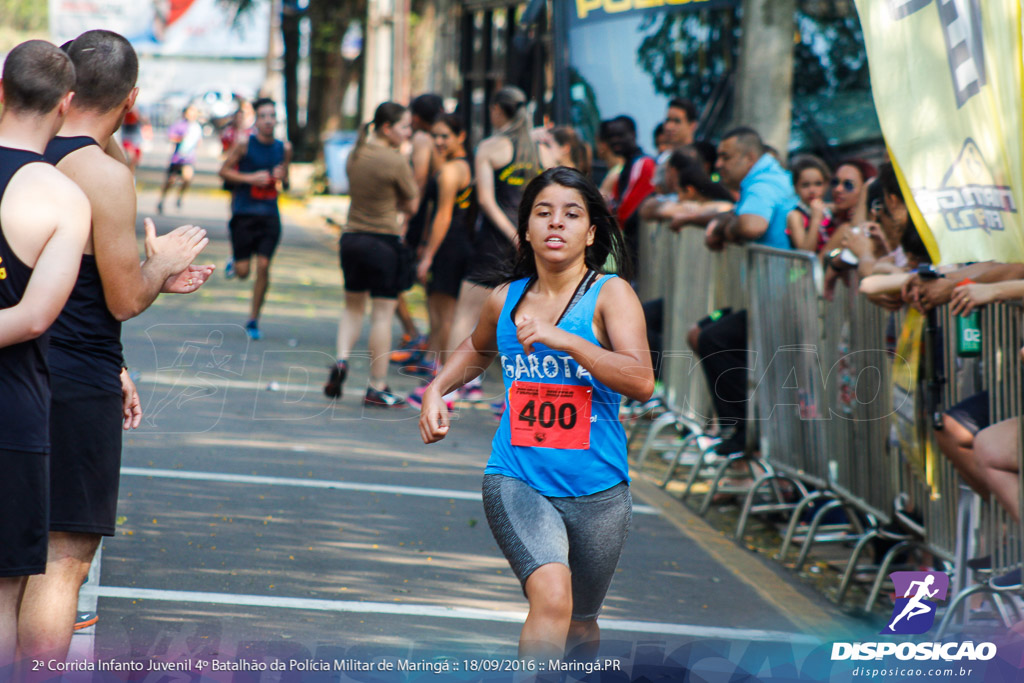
[734, 0, 797, 152]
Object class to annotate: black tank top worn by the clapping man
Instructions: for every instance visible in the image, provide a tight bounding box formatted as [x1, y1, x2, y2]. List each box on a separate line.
[46, 135, 122, 394]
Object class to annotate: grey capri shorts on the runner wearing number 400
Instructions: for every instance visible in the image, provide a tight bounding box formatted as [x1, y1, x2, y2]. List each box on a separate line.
[483, 474, 633, 622]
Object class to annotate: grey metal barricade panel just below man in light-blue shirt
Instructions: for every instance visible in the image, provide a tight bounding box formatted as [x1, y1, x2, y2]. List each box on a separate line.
[735, 246, 862, 569]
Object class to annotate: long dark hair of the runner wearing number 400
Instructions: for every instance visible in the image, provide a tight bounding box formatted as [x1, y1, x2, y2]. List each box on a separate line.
[502, 166, 633, 282]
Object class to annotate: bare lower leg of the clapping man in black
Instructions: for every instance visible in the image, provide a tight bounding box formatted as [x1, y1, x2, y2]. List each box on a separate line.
[17, 531, 100, 660]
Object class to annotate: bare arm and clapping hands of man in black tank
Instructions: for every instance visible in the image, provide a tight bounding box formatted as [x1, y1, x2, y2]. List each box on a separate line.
[84, 157, 209, 321]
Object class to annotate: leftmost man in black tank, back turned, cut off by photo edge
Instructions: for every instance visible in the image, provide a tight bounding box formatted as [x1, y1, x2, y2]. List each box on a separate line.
[0, 40, 89, 680]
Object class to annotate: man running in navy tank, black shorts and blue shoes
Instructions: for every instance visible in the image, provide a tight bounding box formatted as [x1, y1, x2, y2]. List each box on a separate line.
[220, 97, 292, 340]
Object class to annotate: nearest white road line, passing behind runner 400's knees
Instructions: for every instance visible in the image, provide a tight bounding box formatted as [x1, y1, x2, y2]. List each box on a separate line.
[82, 585, 820, 644]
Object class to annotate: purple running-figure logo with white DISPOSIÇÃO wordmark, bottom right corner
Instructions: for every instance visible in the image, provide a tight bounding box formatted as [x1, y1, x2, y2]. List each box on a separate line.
[831, 571, 995, 661]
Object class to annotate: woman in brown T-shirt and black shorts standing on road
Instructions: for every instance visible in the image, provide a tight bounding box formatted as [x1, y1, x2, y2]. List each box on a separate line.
[324, 102, 419, 408]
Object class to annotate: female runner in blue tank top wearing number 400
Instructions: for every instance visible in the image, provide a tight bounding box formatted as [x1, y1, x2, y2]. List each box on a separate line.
[420, 167, 654, 659]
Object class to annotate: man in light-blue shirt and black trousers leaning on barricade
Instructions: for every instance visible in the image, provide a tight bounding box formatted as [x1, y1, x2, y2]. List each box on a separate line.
[690, 128, 799, 455]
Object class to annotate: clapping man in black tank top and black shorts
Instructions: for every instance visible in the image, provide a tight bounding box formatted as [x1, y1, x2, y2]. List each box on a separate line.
[18, 31, 213, 659]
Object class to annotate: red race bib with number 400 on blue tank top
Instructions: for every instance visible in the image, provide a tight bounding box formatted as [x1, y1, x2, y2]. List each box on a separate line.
[509, 382, 594, 450]
